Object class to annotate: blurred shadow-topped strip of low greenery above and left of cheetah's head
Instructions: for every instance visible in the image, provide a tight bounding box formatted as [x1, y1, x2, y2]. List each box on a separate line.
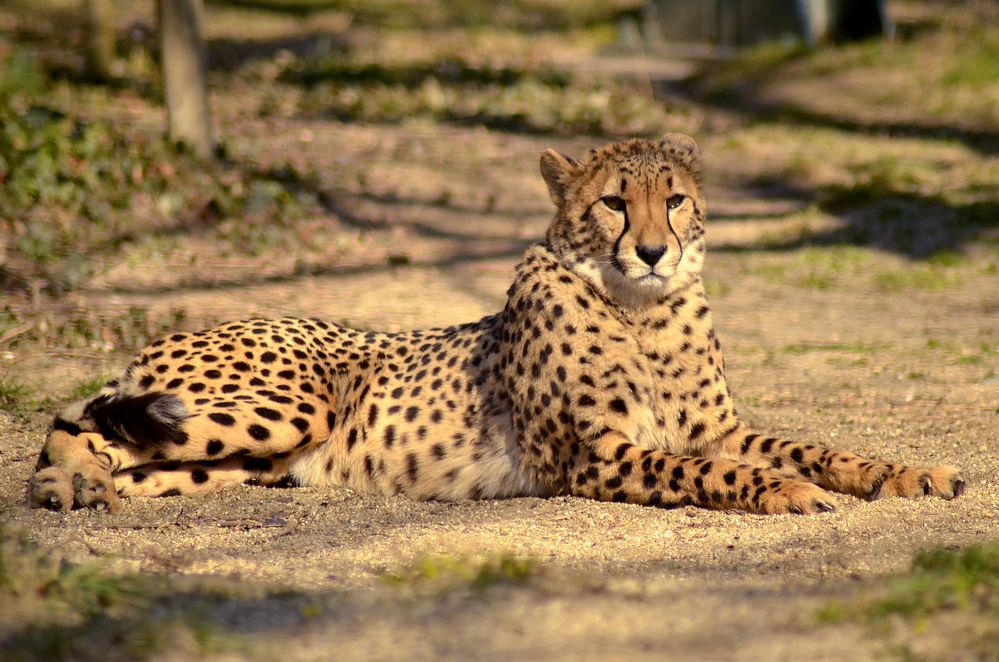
[290, 56, 677, 135]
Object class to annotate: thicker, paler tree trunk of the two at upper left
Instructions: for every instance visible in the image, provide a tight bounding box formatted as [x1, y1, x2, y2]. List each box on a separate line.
[157, 0, 215, 159]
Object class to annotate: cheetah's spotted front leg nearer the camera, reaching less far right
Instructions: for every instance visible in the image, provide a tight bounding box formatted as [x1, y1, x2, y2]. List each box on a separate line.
[569, 432, 835, 514]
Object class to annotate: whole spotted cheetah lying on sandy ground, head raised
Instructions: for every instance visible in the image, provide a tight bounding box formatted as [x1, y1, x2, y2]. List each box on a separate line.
[28, 133, 965, 514]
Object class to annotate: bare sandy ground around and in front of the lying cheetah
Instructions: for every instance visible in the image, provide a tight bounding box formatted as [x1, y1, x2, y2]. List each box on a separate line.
[0, 1, 999, 661]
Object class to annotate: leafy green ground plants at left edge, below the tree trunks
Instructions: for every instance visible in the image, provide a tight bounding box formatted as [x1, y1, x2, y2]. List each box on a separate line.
[0, 50, 320, 293]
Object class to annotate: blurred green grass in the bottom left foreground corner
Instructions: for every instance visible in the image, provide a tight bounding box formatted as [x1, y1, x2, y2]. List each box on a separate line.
[0, 527, 312, 662]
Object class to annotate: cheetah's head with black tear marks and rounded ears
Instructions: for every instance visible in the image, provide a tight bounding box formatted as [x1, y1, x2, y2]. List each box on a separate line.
[541, 133, 707, 307]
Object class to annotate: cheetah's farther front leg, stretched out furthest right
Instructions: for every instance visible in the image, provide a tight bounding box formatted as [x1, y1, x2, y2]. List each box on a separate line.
[719, 428, 965, 501]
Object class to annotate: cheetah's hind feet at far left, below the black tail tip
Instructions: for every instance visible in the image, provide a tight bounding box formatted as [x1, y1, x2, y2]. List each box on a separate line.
[28, 430, 121, 513]
